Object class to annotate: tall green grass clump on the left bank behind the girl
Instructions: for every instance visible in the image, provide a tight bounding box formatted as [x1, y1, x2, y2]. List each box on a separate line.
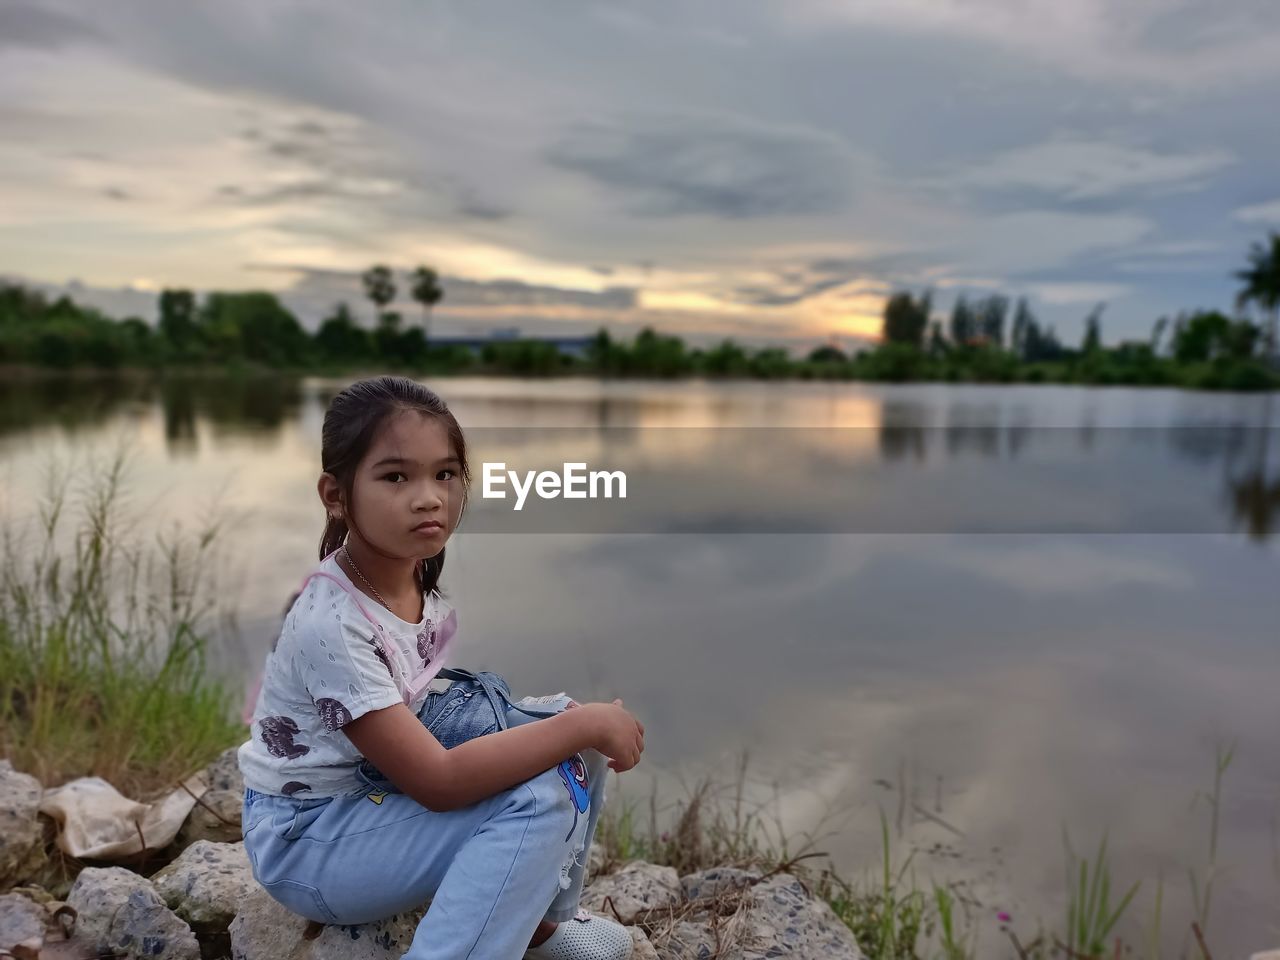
[0, 453, 243, 797]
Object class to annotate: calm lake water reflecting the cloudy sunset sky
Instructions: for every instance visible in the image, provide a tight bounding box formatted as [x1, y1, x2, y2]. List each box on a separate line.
[0, 378, 1280, 957]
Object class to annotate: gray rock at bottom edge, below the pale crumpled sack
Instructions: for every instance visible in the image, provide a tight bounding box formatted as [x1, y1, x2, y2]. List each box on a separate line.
[67, 867, 200, 960]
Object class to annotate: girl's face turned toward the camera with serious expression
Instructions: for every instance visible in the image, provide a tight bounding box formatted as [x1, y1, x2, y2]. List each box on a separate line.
[352, 410, 463, 559]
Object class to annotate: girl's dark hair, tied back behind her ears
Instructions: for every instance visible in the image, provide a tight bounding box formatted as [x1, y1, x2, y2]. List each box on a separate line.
[320, 376, 471, 593]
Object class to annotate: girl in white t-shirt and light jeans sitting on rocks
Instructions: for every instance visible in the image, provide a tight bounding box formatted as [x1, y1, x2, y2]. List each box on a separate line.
[239, 376, 644, 960]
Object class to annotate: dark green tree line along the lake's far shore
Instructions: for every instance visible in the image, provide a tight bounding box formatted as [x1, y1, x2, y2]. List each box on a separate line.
[0, 233, 1280, 389]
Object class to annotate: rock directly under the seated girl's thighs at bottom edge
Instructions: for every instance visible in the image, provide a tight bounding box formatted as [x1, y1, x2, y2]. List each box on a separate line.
[230, 887, 426, 960]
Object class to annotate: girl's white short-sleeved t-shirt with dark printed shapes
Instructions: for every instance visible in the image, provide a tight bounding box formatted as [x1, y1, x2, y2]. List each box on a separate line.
[239, 554, 457, 797]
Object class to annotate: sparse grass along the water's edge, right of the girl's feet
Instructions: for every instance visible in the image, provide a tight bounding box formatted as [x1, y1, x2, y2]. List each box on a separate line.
[596, 748, 1249, 960]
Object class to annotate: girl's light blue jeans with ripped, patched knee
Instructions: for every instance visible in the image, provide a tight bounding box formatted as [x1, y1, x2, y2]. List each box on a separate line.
[243, 698, 608, 960]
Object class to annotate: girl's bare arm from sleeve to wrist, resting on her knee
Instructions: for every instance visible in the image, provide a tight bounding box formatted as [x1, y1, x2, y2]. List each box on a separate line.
[342, 704, 614, 812]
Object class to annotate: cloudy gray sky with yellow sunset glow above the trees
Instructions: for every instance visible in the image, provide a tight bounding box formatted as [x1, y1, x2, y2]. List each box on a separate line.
[0, 0, 1280, 353]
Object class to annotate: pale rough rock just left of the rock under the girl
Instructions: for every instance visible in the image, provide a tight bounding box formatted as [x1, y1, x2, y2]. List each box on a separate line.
[151, 840, 256, 940]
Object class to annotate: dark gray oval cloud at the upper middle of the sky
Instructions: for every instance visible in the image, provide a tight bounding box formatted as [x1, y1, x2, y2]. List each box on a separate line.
[547, 114, 850, 220]
